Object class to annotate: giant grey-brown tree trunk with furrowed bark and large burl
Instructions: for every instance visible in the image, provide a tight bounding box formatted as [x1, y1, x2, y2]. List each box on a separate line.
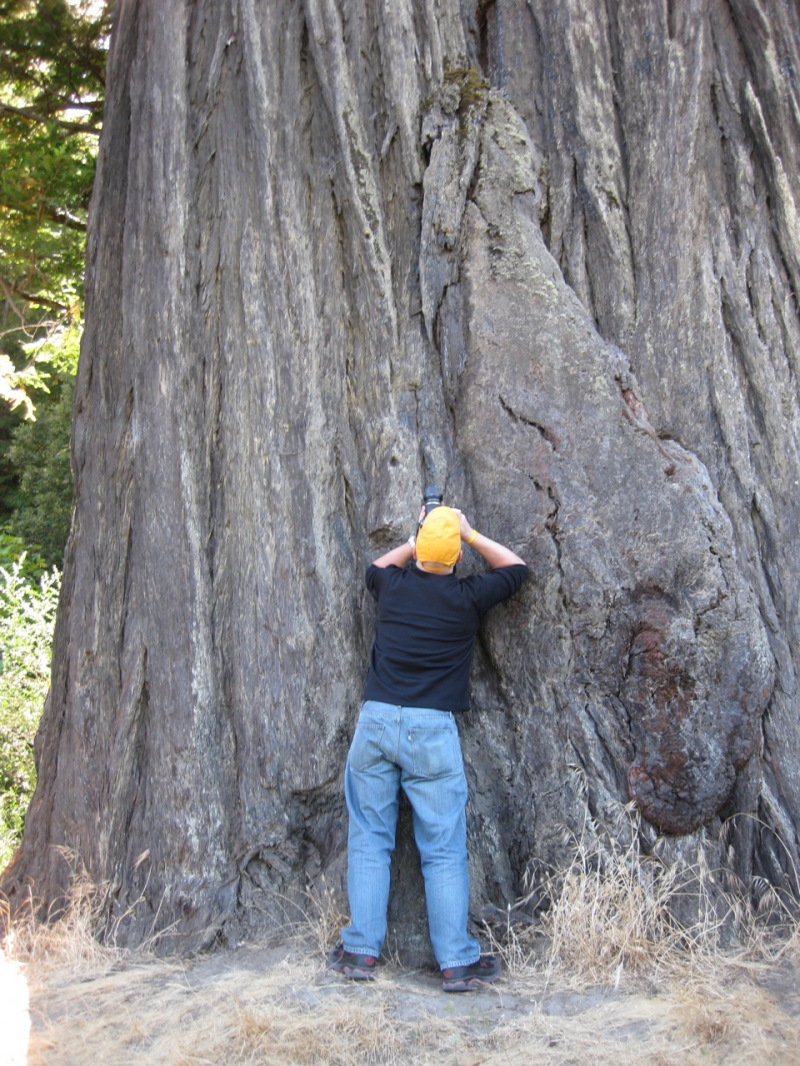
[5, 0, 800, 955]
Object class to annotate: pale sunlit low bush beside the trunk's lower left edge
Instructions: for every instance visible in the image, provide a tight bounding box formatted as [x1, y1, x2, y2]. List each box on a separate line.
[0, 554, 61, 869]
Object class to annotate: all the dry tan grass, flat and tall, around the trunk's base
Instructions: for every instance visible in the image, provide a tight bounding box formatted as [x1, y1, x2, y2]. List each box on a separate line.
[0, 822, 800, 1066]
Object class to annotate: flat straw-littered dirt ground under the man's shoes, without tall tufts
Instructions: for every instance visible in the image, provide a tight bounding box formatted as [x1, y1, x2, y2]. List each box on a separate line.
[0, 941, 800, 1066]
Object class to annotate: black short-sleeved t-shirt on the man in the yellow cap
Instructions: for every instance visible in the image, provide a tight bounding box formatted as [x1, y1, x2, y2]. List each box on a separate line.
[364, 564, 528, 711]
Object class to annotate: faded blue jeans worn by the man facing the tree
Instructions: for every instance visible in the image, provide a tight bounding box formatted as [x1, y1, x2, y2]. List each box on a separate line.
[341, 700, 480, 970]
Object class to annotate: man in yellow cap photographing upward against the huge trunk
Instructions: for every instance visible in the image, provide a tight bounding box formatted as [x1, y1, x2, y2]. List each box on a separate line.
[327, 498, 528, 991]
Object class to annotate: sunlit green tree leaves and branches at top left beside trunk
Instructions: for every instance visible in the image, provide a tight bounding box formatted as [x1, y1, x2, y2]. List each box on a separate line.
[0, 0, 112, 418]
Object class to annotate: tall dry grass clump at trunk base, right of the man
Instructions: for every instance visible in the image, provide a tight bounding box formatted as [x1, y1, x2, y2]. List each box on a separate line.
[487, 807, 800, 988]
